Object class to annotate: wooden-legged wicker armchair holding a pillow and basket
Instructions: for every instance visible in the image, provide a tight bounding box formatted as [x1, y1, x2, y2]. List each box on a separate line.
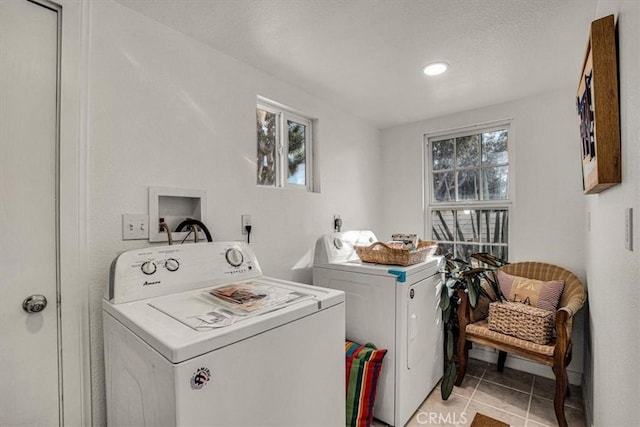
[455, 262, 586, 427]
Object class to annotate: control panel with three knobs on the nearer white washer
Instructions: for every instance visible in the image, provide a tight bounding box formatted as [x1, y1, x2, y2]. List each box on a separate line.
[105, 242, 262, 304]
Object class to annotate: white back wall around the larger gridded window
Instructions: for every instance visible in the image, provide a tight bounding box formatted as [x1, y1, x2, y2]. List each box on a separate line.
[382, 89, 585, 384]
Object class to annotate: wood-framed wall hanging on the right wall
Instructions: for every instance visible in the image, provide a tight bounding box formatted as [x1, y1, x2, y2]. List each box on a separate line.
[576, 15, 622, 194]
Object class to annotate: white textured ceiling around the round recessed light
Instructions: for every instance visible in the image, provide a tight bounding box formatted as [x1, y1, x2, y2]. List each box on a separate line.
[112, 0, 597, 129]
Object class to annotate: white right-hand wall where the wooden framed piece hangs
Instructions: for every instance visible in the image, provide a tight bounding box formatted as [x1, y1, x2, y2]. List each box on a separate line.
[585, 0, 640, 426]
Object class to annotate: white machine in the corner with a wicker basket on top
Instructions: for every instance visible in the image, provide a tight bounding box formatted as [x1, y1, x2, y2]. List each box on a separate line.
[313, 231, 444, 426]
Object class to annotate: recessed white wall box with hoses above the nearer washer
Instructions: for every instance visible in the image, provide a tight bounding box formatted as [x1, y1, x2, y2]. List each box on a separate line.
[149, 187, 210, 243]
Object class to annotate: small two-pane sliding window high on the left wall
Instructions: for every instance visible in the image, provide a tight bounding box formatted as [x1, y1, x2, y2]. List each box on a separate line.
[256, 99, 313, 191]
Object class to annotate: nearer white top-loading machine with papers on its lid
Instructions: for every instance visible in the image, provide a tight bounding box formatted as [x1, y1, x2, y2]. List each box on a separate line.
[103, 242, 345, 426]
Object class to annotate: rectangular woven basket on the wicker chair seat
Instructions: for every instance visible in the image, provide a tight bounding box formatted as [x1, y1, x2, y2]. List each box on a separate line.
[489, 302, 555, 345]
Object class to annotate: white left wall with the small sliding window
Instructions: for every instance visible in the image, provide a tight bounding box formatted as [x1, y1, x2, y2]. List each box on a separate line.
[87, 1, 382, 425]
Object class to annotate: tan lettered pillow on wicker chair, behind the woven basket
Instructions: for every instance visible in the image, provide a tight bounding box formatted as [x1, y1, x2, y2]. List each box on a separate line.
[498, 270, 564, 311]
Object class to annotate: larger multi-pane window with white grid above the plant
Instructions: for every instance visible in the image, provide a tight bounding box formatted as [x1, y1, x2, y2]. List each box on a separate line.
[425, 123, 511, 260]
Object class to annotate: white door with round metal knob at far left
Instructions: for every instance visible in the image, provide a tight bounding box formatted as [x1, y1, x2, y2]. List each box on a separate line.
[0, 0, 60, 426]
